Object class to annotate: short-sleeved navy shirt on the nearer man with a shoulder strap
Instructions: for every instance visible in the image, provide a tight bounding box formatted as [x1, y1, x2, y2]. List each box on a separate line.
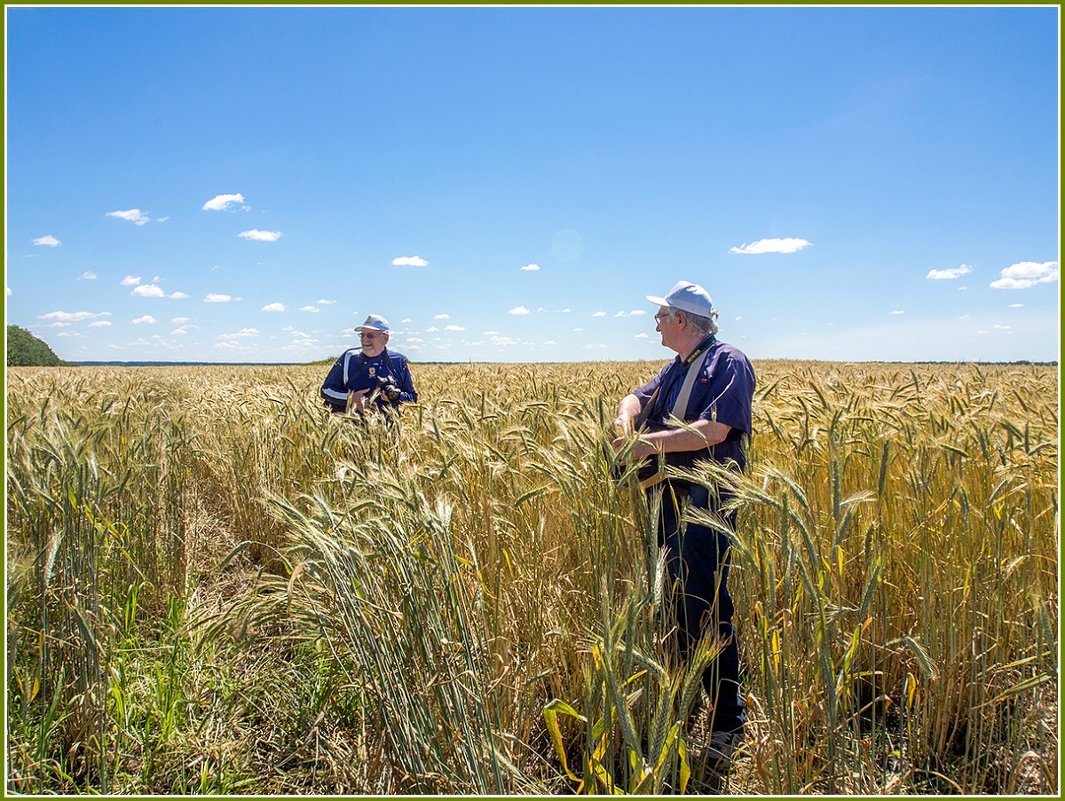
[633, 340, 755, 471]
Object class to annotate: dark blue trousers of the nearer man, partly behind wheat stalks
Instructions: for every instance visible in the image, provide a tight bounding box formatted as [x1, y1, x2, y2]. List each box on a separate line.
[658, 481, 747, 732]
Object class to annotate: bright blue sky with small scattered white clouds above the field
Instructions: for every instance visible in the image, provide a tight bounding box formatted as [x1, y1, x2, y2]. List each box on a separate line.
[5, 6, 1061, 362]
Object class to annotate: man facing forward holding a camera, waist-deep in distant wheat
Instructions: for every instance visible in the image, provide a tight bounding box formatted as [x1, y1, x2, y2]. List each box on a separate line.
[322, 314, 417, 413]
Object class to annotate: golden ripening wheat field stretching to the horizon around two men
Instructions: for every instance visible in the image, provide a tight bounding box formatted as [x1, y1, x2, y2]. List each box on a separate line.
[5, 361, 1060, 796]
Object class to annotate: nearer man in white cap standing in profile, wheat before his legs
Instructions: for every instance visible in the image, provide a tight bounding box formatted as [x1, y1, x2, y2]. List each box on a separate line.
[613, 281, 755, 768]
